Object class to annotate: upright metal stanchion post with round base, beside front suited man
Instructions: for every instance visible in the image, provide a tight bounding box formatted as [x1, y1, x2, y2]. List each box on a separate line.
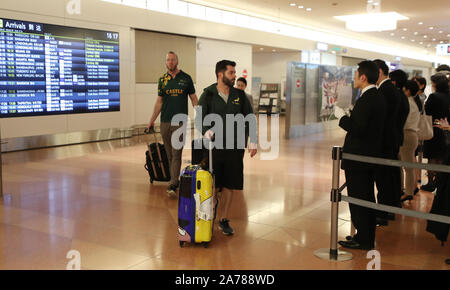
[314, 146, 353, 261]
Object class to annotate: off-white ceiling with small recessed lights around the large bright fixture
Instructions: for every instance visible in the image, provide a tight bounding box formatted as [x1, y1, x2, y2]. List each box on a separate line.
[188, 0, 450, 54]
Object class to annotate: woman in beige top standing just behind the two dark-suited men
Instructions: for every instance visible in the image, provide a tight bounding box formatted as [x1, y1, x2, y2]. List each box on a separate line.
[400, 80, 420, 201]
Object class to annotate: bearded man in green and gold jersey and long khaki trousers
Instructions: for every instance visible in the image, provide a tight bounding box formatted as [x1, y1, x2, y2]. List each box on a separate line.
[148, 51, 198, 198]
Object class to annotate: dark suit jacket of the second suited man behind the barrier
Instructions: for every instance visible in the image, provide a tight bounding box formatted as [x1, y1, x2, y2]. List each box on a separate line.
[378, 80, 409, 158]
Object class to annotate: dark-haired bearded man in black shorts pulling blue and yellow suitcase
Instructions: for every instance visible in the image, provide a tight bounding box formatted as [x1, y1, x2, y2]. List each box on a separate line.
[196, 60, 257, 235]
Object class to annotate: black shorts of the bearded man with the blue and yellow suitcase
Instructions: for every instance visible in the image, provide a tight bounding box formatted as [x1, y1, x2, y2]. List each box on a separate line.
[213, 149, 245, 190]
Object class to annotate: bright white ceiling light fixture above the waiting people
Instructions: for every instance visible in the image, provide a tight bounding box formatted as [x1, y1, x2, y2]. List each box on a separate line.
[334, 12, 409, 32]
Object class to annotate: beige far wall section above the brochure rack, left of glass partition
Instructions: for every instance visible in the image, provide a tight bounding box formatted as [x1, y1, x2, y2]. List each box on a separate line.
[253, 51, 301, 84]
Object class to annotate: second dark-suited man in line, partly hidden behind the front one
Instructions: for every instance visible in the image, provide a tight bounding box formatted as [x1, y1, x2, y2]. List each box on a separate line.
[374, 59, 409, 225]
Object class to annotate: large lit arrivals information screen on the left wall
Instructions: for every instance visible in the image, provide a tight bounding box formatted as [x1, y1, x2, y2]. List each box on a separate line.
[0, 18, 120, 118]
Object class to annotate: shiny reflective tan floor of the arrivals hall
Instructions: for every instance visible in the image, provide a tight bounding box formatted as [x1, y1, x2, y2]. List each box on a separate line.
[0, 122, 450, 270]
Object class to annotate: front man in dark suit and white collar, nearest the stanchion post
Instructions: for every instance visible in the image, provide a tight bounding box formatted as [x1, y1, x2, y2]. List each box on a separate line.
[339, 61, 386, 250]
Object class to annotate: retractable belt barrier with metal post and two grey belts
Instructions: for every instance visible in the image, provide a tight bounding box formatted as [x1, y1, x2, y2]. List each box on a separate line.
[314, 146, 450, 261]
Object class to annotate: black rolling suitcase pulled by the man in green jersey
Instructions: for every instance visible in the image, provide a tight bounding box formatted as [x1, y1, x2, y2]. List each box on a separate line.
[144, 130, 170, 183]
